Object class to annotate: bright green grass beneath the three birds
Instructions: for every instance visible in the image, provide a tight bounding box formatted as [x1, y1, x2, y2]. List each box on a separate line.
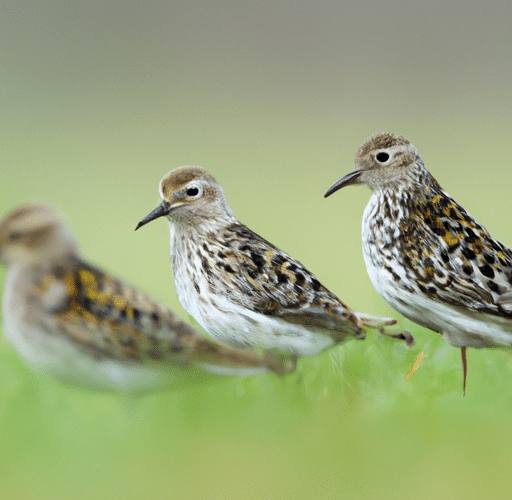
[0, 314, 512, 499]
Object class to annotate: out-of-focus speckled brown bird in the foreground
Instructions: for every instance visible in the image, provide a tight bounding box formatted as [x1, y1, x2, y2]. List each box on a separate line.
[0, 203, 287, 393]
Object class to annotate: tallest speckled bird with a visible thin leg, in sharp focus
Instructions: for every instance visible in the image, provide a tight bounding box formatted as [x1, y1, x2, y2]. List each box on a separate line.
[325, 132, 512, 393]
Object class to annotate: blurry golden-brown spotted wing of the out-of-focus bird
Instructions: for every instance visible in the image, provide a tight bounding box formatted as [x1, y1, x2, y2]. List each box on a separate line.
[36, 262, 197, 362]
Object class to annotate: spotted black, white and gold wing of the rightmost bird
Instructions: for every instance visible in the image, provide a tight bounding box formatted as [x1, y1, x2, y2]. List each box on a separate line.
[408, 190, 512, 316]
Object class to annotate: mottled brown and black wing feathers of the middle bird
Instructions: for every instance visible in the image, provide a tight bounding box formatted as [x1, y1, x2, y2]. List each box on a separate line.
[201, 222, 395, 338]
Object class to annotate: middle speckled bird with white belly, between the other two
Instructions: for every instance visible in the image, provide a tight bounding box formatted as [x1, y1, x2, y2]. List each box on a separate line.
[136, 166, 412, 360]
